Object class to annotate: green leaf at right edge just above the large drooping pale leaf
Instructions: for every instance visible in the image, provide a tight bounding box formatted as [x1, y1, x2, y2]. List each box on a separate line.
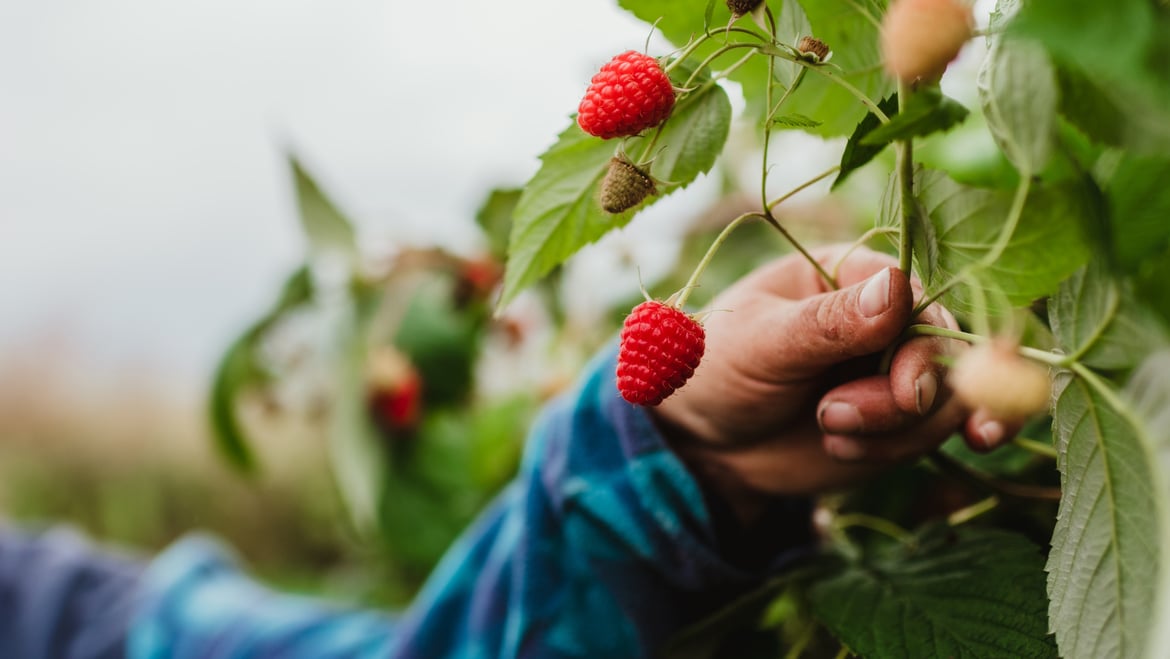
[1048, 260, 1166, 370]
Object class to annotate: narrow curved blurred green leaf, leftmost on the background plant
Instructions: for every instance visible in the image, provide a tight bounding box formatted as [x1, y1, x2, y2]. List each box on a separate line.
[208, 267, 312, 473]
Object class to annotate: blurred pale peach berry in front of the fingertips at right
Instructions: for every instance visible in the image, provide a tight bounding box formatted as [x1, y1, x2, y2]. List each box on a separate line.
[947, 339, 1052, 421]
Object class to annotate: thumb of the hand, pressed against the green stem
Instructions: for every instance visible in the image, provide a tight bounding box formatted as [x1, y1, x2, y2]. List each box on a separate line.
[764, 267, 914, 377]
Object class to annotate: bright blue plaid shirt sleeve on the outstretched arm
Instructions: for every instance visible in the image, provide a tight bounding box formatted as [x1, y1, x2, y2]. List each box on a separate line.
[128, 349, 812, 659]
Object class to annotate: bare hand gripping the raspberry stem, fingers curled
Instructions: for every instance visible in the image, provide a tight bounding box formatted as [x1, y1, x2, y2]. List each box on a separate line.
[652, 246, 1018, 521]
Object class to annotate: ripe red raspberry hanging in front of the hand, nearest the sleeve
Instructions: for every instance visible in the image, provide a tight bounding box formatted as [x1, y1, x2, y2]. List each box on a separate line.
[618, 300, 706, 406]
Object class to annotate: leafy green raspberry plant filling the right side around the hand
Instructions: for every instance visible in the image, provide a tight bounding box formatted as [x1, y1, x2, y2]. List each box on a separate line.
[501, 0, 1170, 659]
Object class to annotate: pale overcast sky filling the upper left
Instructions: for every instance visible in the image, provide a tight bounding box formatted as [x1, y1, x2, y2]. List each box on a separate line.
[0, 0, 669, 381]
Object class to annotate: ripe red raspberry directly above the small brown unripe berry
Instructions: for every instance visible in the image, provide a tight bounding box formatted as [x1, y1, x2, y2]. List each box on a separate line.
[577, 50, 674, 139]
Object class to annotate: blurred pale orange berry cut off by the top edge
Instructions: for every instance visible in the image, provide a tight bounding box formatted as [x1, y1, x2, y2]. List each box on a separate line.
[881, 0, 975, 82]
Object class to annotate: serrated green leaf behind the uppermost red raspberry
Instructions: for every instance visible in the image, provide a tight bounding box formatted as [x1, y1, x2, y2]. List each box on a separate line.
[500, 71, 731, 306]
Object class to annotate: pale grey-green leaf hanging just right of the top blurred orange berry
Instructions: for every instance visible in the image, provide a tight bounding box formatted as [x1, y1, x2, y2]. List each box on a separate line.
[977, 0, 1060, 176]
